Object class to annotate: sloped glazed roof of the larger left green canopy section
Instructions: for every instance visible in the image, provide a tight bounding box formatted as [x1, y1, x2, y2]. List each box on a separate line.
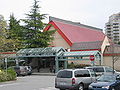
[16, 47, 65, 57]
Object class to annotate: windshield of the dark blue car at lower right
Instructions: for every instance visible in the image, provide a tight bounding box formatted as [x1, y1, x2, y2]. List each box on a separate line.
[97, 75, 116, 82]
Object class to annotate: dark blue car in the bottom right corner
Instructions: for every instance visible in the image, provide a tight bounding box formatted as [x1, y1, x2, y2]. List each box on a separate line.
[89, 73, 120, 90]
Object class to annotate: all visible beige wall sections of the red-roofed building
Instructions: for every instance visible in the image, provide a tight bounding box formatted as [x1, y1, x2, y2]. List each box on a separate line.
[49, 27, 120, 70]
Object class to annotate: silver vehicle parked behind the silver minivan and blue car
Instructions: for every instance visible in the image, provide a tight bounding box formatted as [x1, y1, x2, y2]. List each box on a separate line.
[85, 66, 120, 76]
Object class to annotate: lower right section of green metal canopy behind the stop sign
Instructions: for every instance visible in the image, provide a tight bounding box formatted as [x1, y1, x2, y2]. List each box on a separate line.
[56, 51, 102, 70]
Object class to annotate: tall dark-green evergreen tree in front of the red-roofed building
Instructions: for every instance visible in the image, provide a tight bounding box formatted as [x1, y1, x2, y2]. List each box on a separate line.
[22, 0, 55, 48]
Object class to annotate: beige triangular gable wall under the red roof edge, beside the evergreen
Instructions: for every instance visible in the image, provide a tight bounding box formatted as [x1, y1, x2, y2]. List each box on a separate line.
[49, 27, 70, 49]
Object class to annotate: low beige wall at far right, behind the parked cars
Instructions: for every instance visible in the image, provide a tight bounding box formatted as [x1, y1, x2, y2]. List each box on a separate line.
[103, 56, 120, 71]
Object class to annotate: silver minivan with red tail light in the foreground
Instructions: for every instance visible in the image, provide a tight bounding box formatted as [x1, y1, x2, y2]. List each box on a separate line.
[55, 69, 96, 90]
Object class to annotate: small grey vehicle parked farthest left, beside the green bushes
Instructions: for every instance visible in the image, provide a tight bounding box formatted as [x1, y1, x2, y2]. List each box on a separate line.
[12, 66, 27, 76]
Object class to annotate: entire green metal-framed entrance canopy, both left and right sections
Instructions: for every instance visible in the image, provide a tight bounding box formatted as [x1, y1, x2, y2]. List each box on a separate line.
[16, 47, 102, 72]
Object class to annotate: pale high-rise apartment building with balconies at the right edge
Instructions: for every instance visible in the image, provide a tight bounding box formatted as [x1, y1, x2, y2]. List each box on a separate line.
[105, 13, 120, 44]
